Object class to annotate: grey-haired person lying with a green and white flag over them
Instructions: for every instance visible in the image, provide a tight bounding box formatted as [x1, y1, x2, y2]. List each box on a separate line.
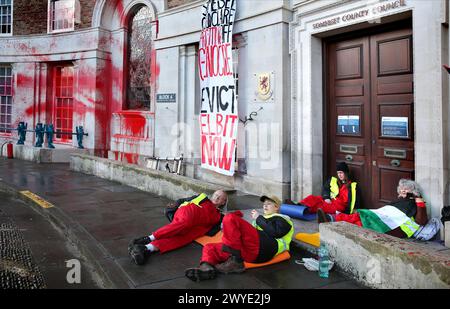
[317, 179, 428, 238]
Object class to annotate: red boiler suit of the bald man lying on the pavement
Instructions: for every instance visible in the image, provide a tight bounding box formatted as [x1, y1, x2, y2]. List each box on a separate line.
[152, 199, 221, 253]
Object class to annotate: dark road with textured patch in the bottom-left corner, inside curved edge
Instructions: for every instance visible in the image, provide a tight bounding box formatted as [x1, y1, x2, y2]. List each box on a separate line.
[0, 192, 102, 289]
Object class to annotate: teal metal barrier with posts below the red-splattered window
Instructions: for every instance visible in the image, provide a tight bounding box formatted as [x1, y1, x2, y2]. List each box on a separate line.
[0, 121, 88, 149]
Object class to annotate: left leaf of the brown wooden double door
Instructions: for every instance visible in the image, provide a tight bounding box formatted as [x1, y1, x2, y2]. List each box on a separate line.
[327, 37, 371, 208]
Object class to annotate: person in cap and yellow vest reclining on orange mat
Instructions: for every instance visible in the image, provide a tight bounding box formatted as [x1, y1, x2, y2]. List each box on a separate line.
[185, 196, 294, 281]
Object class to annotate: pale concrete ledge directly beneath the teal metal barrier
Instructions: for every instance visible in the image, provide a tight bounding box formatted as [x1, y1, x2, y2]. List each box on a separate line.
[14, 145, 89, 163]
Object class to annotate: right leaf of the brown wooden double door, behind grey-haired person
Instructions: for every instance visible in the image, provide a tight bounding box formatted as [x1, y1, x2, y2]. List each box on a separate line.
[370, 29, 414, 207]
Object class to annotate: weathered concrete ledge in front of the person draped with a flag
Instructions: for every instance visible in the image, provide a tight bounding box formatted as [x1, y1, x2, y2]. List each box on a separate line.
[319, 222, 450, 289]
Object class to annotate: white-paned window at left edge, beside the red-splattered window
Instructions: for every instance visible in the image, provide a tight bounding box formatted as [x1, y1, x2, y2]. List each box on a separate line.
[0, 64, 12, 134]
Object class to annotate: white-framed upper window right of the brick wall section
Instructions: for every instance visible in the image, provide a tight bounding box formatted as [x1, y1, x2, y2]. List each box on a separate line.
[48, 0, 80, 33]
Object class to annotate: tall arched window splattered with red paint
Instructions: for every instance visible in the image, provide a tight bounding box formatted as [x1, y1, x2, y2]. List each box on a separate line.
[127, 6, 152, 110]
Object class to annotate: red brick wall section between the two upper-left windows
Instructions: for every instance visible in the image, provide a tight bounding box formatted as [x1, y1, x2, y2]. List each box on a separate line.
[13, 0, 48, 35]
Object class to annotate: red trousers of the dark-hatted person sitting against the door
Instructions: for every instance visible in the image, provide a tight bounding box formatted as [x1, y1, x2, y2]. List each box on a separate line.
[300, 185, 348, 214]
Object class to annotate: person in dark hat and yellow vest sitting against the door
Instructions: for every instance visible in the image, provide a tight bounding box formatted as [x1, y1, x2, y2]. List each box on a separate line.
[299, 162, 360, 214]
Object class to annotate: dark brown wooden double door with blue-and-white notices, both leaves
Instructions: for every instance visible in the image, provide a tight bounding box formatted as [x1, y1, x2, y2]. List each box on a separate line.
[326, 29, 414, 208]
